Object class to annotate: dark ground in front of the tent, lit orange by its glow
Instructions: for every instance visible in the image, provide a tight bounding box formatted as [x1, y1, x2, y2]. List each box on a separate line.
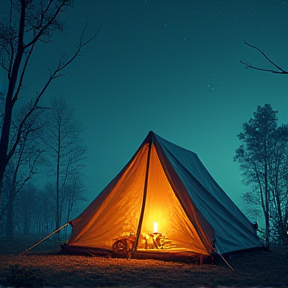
[0, 239, 288, 288]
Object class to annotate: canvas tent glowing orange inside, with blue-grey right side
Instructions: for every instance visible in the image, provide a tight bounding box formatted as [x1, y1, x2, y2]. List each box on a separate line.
[65, 132, 261, 255]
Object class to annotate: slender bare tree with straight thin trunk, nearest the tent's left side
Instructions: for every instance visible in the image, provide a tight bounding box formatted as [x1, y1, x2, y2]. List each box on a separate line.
[42, 99, 86, 229]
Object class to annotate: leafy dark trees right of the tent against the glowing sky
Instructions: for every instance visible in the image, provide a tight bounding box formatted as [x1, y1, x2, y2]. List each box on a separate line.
[234, 104, 288, 246]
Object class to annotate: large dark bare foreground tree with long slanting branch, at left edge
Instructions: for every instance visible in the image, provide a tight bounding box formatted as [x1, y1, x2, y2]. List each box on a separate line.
[0, 0, 100, 206]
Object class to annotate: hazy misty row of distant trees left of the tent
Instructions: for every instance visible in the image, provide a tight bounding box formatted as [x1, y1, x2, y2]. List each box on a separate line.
[0, 98, 87, 238]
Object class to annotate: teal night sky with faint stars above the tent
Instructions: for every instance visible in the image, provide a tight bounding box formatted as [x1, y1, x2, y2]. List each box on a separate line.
[0, 0, 288, 213]
